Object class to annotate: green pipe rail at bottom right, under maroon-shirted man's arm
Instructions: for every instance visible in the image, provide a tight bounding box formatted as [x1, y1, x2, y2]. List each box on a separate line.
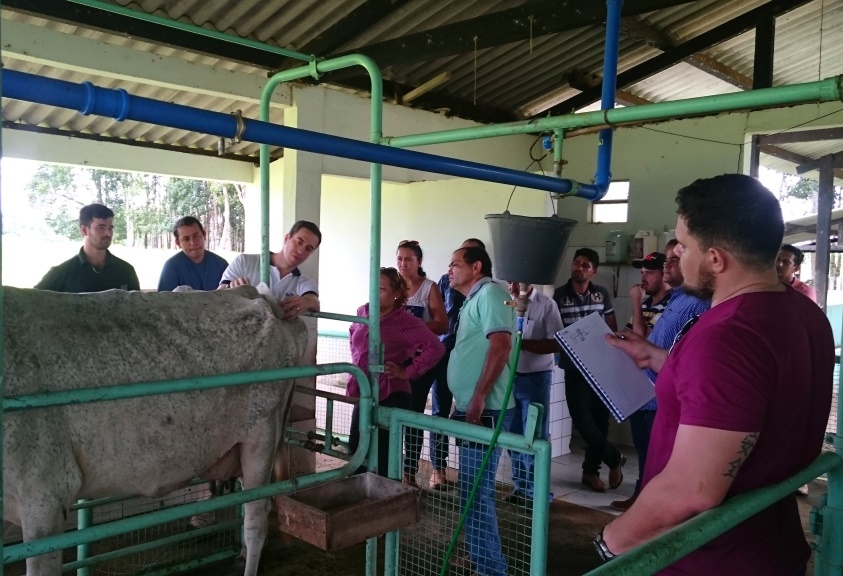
[588, 452, 843, 576]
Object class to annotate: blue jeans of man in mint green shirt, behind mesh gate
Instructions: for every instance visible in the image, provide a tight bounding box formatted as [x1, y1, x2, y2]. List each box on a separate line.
[456, 409, 515, 576]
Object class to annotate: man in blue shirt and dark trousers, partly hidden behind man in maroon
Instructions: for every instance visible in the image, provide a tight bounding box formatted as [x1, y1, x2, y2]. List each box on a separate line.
[610, 240, 711, 512]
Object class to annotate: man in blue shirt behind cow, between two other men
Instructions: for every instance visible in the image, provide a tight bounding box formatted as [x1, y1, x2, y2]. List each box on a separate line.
[158, 216, 228, 292]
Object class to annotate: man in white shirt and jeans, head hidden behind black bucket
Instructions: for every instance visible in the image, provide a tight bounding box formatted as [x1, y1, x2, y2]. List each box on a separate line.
[506, 282, 564, 505]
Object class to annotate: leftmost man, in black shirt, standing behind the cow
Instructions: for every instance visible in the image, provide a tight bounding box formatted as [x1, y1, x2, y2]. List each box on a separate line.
[35, 204, 140, 292]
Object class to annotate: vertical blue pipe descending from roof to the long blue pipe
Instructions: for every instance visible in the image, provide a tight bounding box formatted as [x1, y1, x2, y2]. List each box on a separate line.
[589, 0, 623, 194]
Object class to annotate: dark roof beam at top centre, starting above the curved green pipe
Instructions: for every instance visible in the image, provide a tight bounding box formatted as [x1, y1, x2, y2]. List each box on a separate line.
[326, 0, 690, 69]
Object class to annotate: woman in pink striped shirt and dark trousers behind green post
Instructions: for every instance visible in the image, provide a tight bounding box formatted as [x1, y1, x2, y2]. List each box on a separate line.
[346, 268, 445, 476]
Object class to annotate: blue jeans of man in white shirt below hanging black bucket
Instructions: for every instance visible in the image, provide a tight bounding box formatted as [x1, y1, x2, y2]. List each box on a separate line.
[509, 370, 550, 500]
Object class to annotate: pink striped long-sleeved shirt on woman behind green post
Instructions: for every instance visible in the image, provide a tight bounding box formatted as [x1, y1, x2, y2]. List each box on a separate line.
[345, 304, 445, 401]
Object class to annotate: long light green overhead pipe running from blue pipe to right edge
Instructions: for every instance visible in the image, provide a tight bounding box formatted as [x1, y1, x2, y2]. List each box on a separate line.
[383, 76, 843, 148]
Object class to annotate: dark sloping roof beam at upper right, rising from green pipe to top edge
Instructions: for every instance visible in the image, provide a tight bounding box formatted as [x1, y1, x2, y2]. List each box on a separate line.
[541, 0, 811, 115]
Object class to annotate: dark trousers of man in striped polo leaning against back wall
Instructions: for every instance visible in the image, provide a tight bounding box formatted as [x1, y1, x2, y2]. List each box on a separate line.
[565, 370, 621, 475]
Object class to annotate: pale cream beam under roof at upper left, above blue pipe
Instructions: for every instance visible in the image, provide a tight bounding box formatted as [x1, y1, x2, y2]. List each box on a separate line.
[3, 20, 292, 107]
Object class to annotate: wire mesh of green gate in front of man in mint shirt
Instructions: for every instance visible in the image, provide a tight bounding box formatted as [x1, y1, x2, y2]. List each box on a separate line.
[398, 419, 549, 576]
